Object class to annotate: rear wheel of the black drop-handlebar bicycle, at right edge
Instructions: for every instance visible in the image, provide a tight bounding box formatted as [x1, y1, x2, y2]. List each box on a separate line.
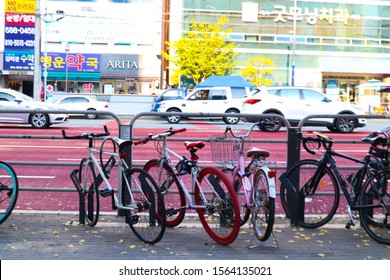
[359, 169, 390, 245]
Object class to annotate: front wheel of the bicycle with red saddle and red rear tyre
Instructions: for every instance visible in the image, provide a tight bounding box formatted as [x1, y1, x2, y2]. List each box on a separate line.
[144, 159, 186, 227]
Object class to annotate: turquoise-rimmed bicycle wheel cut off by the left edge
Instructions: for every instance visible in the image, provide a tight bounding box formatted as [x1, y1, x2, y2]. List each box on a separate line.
[0, 161, 19, 224]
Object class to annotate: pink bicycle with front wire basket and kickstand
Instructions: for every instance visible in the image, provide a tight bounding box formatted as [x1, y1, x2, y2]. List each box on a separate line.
[210, 123, 276, 241]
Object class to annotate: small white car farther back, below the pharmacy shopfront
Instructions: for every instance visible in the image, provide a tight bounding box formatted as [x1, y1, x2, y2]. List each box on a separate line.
[54, 95, 109, 119]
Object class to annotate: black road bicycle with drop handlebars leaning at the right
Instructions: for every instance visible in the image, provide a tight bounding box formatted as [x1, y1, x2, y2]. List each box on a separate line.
[280, 128, 390, 244]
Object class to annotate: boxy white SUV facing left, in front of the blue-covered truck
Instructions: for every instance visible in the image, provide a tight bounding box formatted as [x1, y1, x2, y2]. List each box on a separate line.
[158, 87, 249, 124]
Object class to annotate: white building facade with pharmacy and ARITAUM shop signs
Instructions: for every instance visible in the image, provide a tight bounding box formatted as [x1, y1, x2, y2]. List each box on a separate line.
[0, 0, 162, 96]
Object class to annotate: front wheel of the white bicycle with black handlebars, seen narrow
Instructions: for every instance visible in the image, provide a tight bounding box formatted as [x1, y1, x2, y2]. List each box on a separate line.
[79, 158, 100, 227]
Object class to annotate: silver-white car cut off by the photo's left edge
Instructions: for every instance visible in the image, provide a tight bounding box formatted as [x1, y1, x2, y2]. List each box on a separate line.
[0, 88, 68, 128]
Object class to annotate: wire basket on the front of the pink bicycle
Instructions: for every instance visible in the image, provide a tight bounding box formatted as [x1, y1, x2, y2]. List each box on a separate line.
[209, 135, 250, 164]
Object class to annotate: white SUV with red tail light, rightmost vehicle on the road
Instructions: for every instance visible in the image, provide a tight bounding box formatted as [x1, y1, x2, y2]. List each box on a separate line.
[242, 87, 367, 133]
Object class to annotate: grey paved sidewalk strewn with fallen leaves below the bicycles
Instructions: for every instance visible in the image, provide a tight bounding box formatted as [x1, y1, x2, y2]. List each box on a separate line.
[0, 212, 390, 260]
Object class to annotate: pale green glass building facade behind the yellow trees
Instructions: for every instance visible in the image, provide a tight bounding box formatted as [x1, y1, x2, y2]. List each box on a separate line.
[171, 0, 390, 109]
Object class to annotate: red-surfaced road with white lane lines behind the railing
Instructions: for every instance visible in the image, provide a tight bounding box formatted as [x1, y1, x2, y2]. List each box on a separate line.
[0, 118, 389, 211]
